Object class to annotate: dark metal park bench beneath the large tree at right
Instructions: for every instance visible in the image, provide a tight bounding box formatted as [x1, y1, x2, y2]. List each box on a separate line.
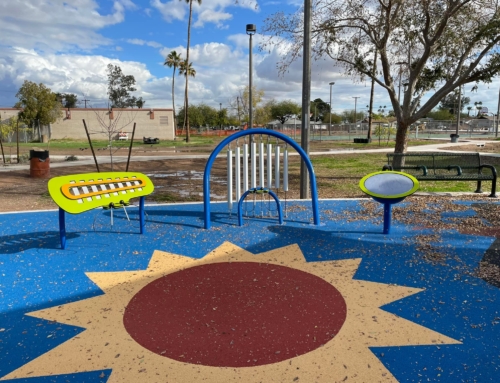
[383, 152, 497, 198]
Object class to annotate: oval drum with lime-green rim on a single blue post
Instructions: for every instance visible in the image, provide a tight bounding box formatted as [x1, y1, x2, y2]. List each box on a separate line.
[359, 171, 419, 234]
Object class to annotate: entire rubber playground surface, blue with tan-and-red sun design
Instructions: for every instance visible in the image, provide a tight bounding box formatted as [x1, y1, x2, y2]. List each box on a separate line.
[0, 133, 500, 383]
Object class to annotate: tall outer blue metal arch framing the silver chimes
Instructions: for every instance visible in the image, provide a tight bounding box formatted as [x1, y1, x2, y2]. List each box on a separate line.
[203, 129, 320, 229]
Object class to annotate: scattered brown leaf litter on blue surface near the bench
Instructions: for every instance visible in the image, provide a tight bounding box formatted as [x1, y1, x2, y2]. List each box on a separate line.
[330, 194, 500, 288]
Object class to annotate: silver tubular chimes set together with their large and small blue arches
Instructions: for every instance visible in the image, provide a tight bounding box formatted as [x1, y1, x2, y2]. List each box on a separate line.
[203, 129, 320, 229]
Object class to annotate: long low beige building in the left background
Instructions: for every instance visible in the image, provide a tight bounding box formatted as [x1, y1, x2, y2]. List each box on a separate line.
[0, 108, 175, 140]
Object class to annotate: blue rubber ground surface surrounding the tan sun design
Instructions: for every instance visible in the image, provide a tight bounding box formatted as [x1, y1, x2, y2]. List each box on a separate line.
[0, 198, 500, 383]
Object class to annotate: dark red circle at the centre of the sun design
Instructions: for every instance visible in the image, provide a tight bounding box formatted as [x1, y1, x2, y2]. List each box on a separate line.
[123, 262, 346, 367]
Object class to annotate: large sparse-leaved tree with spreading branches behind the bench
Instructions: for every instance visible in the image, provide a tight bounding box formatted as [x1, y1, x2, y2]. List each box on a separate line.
[261, 0, 500, 152]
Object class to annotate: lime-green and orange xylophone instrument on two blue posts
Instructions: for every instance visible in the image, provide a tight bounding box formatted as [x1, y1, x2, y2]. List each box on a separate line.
[48, 172, 154, 249]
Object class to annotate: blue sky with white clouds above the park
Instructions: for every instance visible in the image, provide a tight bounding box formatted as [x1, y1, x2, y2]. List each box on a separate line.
[0, 0, 500, 116]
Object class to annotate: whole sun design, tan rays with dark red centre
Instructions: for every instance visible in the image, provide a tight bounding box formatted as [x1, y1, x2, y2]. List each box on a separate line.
[2, 242, 460, 383]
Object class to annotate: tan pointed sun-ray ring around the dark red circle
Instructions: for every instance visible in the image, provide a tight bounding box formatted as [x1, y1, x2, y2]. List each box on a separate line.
[3, 242, 460, 383]
